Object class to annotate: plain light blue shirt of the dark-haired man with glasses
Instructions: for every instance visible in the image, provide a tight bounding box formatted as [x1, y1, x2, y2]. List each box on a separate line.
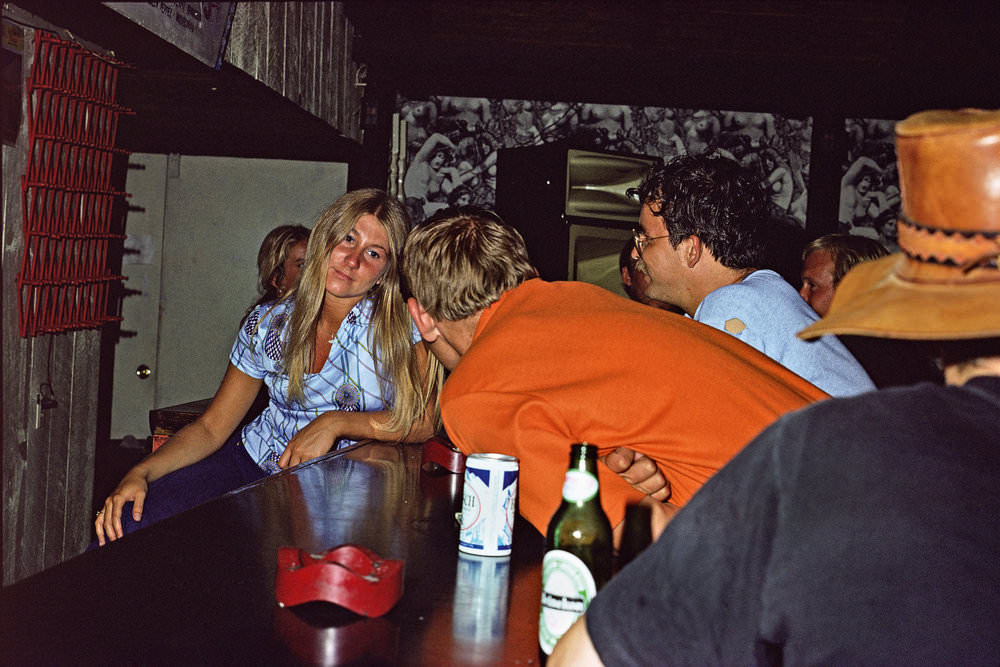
[694, 269, 875, 396]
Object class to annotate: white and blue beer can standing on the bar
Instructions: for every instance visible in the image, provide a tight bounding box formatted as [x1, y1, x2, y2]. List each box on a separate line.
[458, 454, 518, 556]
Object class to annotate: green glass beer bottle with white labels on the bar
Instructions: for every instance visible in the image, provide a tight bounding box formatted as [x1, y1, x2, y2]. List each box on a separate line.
[538, 443, 613, 656]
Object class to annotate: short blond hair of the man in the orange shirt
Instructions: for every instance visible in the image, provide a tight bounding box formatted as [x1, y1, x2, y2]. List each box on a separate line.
[403, 207, 537, 321]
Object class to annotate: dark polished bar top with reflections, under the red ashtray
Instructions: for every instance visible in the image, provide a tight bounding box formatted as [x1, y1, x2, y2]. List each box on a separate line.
[0, 443, 543, 665]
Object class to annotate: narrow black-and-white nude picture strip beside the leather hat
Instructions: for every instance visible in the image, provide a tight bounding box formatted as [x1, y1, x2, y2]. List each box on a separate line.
[838, 118, 900, 251]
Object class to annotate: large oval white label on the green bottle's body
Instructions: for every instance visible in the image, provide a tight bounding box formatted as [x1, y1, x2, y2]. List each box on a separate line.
[538, 552, 597, 655]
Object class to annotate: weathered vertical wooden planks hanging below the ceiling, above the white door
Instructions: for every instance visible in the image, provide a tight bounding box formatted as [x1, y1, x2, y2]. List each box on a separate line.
[226, 2, 364, 142]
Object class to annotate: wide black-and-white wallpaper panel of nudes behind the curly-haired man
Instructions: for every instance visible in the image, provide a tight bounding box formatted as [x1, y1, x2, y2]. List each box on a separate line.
[397, 96, 812, 227]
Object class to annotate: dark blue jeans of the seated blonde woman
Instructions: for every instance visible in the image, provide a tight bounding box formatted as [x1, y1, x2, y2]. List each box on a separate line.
[90, 431, 267, 549]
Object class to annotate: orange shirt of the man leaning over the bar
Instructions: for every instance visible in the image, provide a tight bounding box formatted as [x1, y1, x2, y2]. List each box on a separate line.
[441, 279, 827, 534]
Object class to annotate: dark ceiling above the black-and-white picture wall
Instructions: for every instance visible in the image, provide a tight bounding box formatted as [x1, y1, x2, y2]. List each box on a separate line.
[347, 0, 1000, 118]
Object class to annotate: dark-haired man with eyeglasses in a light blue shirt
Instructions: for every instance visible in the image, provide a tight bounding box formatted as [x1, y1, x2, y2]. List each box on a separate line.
[629, 155, 875, 396]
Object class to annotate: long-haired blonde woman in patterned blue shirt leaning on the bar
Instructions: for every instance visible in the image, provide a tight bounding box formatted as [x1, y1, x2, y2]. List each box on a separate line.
[94, 190, 442, 545]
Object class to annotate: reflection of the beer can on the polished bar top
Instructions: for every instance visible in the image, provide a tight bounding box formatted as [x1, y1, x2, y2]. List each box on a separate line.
[451, 552, 510, 657]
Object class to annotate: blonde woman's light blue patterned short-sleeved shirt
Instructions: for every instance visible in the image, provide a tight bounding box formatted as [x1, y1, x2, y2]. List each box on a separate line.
[229, 299, 420, 472]
